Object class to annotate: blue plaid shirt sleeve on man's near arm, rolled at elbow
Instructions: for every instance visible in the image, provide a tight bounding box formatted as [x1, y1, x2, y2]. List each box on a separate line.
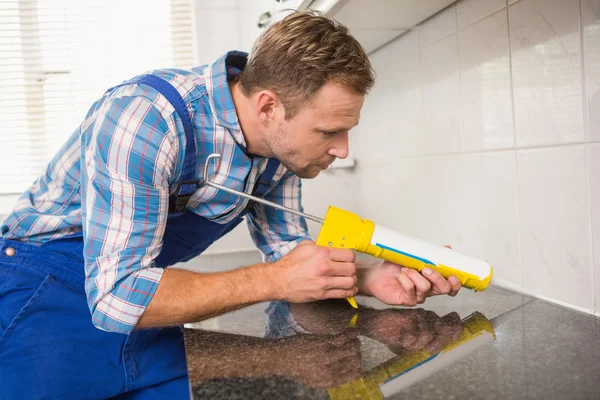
[81, 96, 178, 333]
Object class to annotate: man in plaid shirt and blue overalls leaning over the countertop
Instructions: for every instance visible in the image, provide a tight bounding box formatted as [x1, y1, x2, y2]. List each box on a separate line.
[0, 13, 460, 399]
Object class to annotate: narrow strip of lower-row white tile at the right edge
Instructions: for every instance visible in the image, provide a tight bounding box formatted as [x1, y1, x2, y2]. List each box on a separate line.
[587, 144, 600, 312]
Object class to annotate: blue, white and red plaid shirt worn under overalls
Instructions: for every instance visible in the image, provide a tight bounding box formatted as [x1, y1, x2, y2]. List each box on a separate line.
[0, 52, 308, 333]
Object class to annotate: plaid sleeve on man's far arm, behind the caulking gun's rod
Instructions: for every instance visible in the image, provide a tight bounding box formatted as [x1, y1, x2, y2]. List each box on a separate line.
[247, 171, 310, 262]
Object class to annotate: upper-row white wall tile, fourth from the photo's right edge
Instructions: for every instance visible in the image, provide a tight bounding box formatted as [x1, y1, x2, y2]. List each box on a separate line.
[421, 34, 461, 154]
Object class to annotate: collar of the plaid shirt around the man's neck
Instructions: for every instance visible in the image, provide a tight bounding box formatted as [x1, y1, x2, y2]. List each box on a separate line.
[207, 51, 248, 147]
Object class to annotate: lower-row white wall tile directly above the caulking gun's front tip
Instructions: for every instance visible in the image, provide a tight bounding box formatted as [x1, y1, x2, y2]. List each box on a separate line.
[455, 151, 521, 285]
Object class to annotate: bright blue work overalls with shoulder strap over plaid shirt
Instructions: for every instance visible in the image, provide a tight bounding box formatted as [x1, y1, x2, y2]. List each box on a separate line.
[0, 75, 279, 399]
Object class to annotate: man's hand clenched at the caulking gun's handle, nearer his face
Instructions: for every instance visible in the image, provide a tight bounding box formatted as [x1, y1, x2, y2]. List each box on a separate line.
[270, 240, 358, 303]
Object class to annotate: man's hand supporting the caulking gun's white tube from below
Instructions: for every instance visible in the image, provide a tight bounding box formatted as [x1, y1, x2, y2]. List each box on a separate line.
[361, 261, 462, 307]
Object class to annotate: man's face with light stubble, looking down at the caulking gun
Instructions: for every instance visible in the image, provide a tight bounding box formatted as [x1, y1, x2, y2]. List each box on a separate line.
[265, 82, 364, 178]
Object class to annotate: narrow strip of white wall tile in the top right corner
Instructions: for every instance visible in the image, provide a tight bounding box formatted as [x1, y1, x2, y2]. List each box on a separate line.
[581, 0, 600, 142]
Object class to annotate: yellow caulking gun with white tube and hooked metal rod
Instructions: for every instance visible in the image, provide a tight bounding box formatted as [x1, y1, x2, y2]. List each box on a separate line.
[203, 154, 492, 308]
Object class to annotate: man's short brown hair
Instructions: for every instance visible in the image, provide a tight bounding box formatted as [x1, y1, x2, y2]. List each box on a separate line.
[240, 11, 375, 119]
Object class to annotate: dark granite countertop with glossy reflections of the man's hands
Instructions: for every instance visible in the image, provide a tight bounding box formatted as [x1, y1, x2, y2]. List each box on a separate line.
[185, 287, 600, 399]
